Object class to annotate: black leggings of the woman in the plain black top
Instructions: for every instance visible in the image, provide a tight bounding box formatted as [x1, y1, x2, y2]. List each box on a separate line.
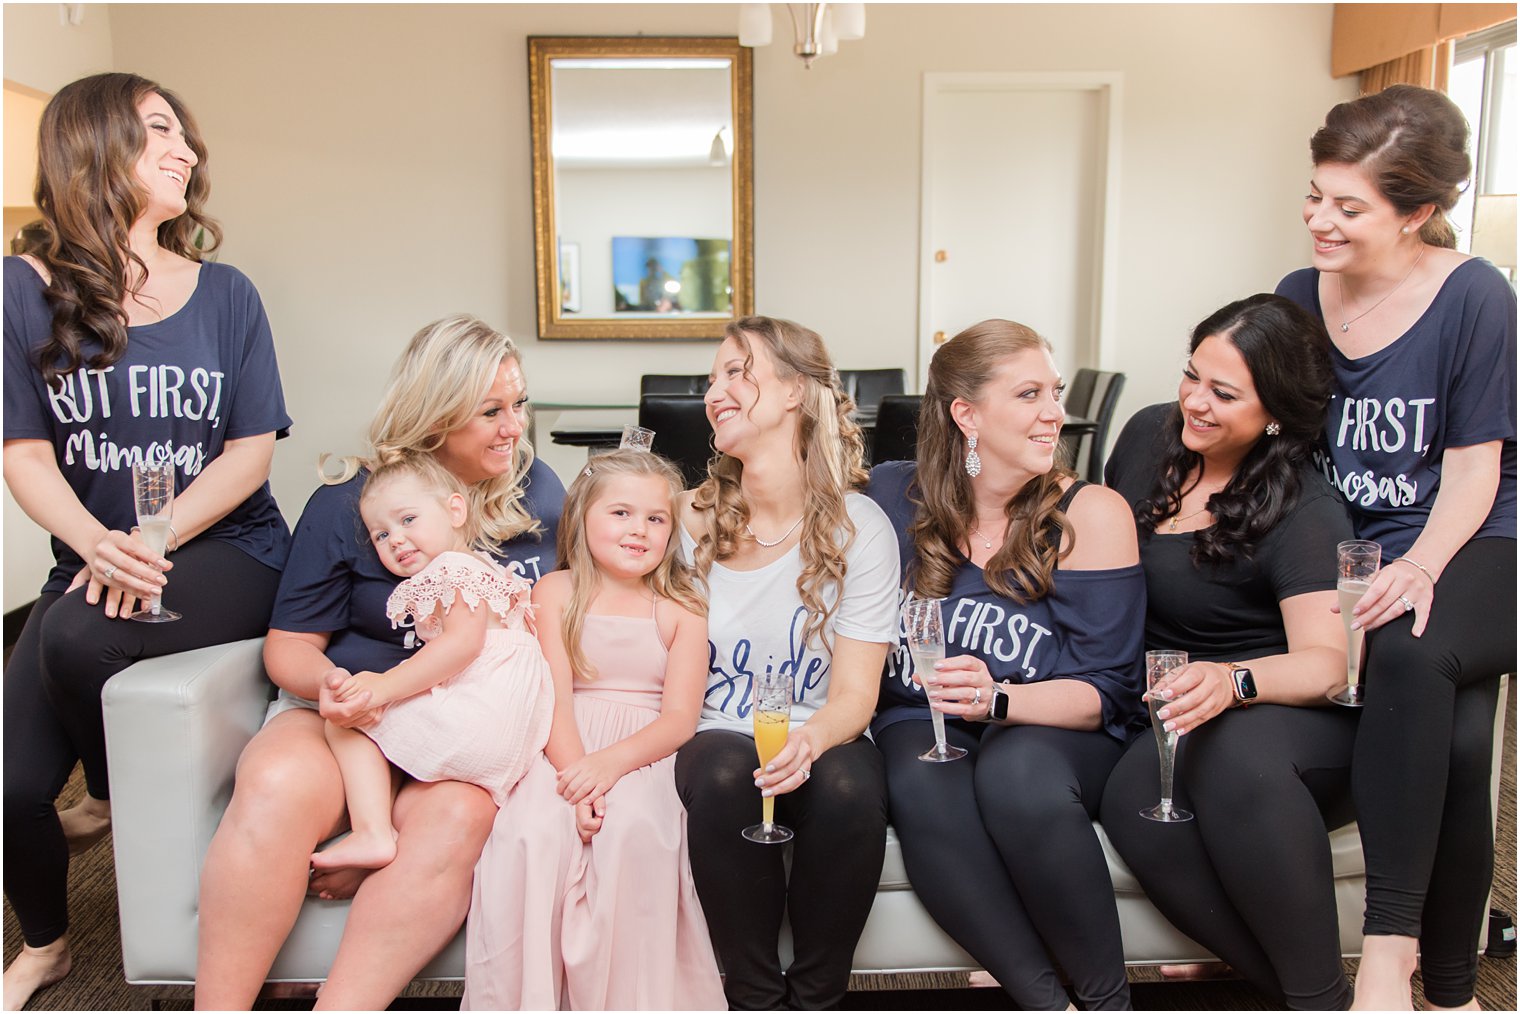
[1102, 704, 1357, 1011]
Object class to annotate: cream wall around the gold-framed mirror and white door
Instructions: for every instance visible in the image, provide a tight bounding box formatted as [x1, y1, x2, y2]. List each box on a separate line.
[5, 5, 1353, 611]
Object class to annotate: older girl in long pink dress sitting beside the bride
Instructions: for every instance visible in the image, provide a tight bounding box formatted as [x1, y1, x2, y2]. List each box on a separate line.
[464, 450, 727, 1009]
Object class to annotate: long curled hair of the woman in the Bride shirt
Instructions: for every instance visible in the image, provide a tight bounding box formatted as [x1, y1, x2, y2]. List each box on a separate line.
[692, 316, 868, 648]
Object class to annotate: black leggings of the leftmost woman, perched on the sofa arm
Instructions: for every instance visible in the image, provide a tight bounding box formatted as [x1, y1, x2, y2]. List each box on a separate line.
[5, 540, 280, 947]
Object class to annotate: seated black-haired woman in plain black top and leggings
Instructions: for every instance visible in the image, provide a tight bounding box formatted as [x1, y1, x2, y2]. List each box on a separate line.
[1102, 295, 1356, 1009]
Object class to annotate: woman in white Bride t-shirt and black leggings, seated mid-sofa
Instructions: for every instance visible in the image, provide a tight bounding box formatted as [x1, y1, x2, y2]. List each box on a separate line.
[676, 316, 898, 1009]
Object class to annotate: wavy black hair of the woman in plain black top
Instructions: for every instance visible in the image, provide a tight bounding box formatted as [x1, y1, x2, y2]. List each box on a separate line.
[1134, 292, 1333, 566]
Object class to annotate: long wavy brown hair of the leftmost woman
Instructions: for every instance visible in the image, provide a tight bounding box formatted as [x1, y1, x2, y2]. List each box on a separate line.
[30, 74, 222, 385]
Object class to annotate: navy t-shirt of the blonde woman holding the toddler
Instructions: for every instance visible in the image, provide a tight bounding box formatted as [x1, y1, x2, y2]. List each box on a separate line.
[269, 459, 565, 672]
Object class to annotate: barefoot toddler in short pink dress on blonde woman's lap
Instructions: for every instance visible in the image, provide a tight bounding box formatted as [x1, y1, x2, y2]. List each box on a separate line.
[312, 455, 553, 870]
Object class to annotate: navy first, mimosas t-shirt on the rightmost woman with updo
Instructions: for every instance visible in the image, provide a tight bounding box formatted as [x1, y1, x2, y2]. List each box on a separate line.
[1277, 257, 1515, 559]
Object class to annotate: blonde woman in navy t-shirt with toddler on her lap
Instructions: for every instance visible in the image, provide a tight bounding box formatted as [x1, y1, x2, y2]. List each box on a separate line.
[196, 316, 568, 1009]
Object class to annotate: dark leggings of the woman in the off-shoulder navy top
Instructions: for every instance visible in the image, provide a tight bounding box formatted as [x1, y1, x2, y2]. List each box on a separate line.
[876, 721, 1129, 1011]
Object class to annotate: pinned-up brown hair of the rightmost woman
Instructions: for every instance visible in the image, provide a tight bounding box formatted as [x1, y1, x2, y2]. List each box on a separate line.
[1309, 85, 1473, 249]
